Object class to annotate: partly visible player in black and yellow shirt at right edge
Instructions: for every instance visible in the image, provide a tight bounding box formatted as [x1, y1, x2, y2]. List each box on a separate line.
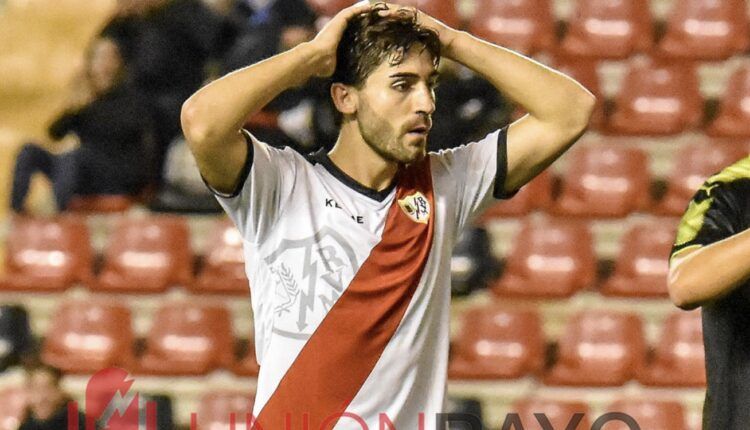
[669, 157, 750, 430]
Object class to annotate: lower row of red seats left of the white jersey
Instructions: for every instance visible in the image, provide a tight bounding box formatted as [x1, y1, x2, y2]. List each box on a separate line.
[42, 300, 258, 376]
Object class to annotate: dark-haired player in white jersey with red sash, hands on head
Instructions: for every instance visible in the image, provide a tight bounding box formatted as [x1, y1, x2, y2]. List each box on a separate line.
[182, 4, 594, 430]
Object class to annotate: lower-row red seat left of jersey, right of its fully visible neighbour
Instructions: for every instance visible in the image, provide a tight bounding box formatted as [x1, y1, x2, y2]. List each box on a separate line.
[139, 302, 234, 375]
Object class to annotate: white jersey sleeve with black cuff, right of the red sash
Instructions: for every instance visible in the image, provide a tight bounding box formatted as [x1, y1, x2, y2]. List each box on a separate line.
[433, 127, 515, 228]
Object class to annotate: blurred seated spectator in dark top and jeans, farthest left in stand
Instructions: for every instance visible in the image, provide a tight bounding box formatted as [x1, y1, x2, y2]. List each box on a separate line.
[11, 38, 148, 212]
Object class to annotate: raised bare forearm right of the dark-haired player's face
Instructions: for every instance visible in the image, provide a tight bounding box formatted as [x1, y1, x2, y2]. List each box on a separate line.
[445, 32, 595, 134]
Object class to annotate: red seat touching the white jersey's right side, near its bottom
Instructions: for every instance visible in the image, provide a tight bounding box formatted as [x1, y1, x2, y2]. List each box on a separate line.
[448, 305, 544, 379]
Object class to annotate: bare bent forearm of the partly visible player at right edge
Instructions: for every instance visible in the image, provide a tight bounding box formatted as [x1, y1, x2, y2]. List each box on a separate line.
[668, 230, 750, 309]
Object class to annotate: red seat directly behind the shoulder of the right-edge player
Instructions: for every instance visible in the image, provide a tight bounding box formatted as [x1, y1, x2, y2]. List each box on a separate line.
[654, 141, 747, 216]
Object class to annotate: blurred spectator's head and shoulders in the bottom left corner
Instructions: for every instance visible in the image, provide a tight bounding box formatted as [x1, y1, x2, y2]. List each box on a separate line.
[19, 364, 86, 430]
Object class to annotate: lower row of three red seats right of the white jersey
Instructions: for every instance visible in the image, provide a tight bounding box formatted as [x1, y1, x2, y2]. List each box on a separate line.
[456, 305, 705, 387]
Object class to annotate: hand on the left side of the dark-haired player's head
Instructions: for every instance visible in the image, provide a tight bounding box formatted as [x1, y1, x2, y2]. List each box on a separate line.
[309, 1, 371, 78]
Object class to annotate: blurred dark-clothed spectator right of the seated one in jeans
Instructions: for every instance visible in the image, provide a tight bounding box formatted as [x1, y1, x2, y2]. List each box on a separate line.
[102, 0, 225, 176]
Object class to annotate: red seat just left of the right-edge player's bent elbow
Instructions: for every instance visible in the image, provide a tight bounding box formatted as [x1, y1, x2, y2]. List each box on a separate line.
[601, 219, 677, 298]
